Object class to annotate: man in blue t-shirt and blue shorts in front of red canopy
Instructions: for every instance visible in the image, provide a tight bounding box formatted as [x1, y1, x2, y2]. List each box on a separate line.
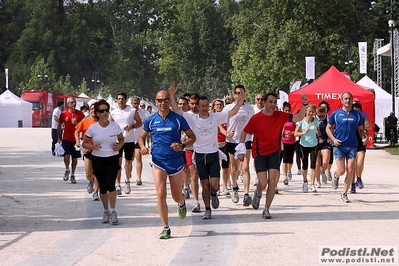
[326, 92, 364, 203]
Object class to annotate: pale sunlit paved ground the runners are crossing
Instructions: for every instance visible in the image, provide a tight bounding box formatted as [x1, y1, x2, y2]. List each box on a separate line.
[0, 128, 399, 266]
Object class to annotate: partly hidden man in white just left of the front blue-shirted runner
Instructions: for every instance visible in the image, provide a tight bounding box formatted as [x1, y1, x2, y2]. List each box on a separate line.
[131, 96, 150, 186]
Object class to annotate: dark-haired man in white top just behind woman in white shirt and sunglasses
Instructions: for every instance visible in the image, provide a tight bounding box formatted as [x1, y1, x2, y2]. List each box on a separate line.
[110, 92, 143, 195]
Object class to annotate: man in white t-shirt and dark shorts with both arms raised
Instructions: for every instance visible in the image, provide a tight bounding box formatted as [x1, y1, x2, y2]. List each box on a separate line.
[169, 82, 244, 219]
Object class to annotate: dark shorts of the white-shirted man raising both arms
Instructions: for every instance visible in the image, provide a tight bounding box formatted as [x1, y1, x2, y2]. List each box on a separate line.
[195, 152, 220, 180]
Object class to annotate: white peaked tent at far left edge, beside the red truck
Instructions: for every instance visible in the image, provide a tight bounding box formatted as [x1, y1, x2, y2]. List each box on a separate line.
[0, 90, 32, 127]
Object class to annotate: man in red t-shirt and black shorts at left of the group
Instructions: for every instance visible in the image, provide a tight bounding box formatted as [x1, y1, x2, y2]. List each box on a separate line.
[57, 97, 84, 184]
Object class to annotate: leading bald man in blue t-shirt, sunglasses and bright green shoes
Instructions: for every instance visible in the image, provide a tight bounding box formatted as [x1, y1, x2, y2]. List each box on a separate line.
[139, 90, 196, 239]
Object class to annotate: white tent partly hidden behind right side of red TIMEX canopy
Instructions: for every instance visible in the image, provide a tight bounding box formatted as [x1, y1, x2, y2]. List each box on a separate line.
[356, 76, 399, 136]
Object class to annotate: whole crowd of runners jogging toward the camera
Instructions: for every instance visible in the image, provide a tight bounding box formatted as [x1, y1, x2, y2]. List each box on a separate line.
[52, 82, 370, 239]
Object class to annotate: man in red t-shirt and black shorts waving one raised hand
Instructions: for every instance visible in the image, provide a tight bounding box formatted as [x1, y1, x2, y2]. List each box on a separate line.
[236, 92, 308, 219]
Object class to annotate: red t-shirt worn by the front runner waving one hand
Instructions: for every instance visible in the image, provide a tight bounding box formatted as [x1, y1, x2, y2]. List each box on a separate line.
[244, 111, 290, 158]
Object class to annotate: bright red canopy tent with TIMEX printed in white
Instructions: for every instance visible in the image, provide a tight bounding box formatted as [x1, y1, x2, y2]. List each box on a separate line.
[289, 66, 375, 147]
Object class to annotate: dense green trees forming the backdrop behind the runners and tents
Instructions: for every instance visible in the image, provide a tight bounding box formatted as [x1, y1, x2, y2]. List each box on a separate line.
[0, 0, 398, 103]
